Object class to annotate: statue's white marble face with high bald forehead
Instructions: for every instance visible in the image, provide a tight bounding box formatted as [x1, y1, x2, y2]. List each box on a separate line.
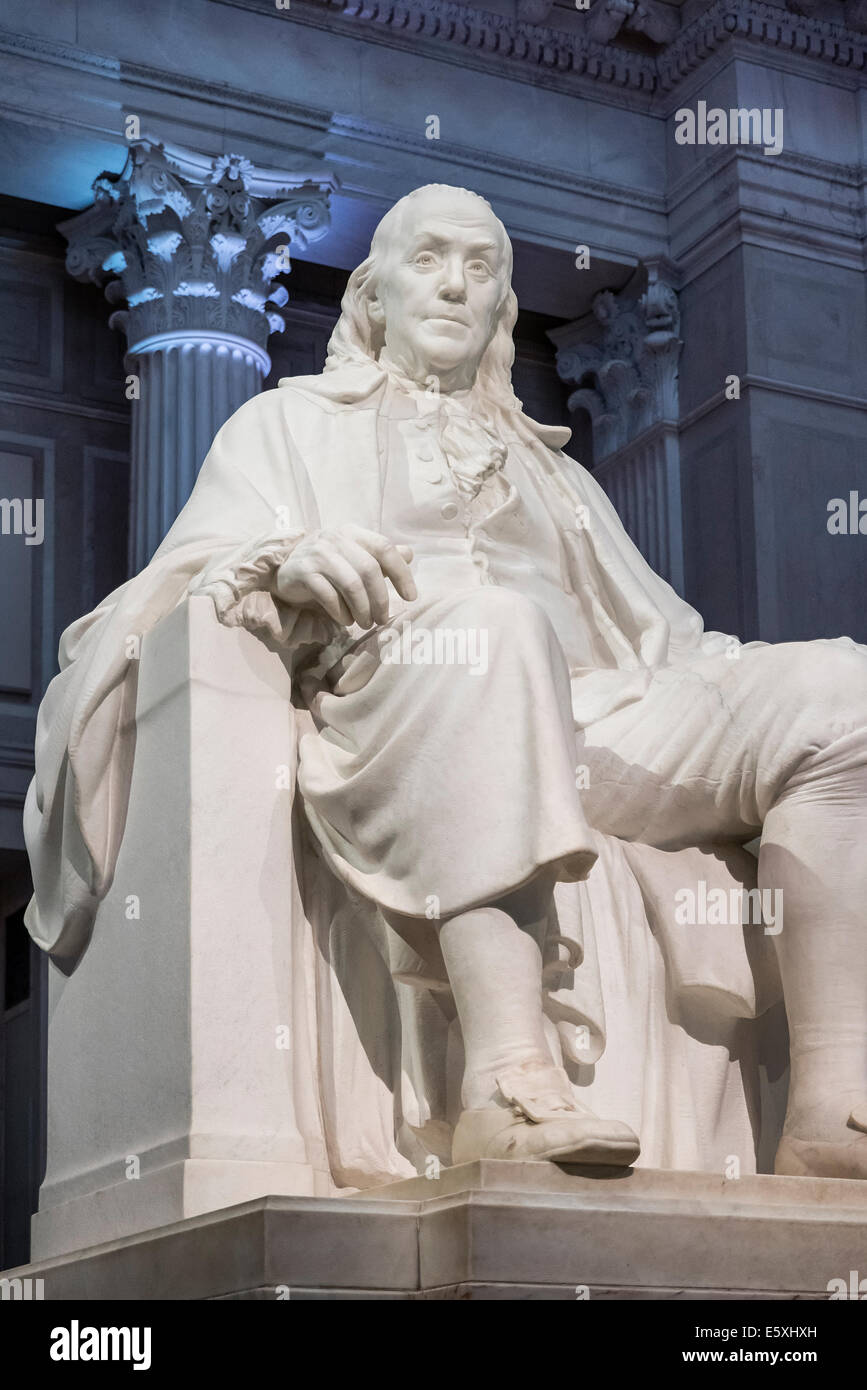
[371, 192, 506, 391]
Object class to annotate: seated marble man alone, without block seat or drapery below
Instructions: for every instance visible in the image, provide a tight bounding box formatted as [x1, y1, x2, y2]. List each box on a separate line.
[26, 185, 867, 1177]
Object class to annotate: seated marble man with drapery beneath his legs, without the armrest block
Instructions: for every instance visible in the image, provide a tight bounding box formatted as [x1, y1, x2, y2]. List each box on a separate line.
[25, 185, 867, 1187]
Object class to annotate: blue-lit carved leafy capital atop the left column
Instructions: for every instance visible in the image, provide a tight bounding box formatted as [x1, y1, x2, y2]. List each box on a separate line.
[60, 138, 338, 348]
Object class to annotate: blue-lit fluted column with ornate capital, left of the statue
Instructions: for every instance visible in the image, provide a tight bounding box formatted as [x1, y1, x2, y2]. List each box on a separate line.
[60, 139, 336, 573]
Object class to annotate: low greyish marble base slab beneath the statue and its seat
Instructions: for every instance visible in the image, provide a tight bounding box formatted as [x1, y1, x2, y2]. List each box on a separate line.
[7, 1161, 867, 1300]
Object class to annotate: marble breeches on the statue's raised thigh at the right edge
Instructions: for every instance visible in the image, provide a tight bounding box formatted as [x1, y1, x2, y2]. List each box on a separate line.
[578, 638, 867, 849]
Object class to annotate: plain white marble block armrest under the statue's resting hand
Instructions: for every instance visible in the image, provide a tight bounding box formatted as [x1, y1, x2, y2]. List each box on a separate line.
[32, 598, 332, 1258]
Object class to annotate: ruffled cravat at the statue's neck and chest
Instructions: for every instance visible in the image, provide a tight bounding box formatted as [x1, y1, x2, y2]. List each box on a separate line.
[379, 352, 509, 502]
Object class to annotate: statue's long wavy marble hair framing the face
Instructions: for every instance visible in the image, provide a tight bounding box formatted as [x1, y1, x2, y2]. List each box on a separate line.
[325, 183, 521, 411]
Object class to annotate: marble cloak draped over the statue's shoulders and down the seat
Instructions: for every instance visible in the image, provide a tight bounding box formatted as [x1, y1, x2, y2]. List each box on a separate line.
[25, 361, 779, 1187]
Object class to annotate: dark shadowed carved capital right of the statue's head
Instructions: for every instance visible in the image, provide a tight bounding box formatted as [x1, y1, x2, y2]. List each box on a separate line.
[549, 271, 684, 463]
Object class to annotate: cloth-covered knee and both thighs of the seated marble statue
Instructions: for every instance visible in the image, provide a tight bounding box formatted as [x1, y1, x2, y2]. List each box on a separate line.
[299, 587, 867, 917]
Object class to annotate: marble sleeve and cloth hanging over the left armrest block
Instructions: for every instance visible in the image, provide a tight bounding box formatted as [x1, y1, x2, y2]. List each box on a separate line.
[24, 391, 336, 973]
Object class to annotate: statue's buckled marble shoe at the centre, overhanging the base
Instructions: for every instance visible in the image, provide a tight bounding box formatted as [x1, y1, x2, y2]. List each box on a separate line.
[452, 1066, 641, 1168]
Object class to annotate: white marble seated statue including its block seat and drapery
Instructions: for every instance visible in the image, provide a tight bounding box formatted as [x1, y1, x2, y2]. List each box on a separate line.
[25, 185, 867, 1250]
